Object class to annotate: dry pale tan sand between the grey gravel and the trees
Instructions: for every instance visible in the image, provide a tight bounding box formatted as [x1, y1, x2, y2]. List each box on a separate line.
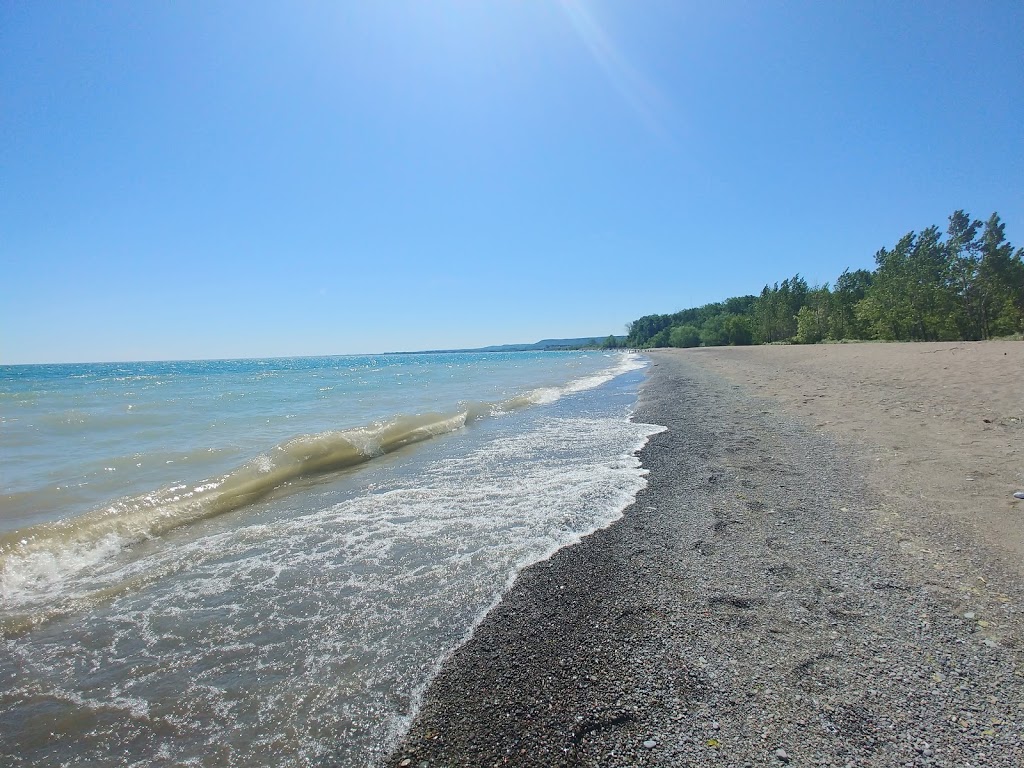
[677, 341, 1024, 577]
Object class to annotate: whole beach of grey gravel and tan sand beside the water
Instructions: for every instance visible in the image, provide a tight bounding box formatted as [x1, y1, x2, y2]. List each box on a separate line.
[387, 342, 1024, 768]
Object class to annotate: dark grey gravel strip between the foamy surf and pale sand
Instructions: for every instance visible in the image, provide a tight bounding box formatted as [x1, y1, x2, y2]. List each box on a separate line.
[386, 353, 1024, 768]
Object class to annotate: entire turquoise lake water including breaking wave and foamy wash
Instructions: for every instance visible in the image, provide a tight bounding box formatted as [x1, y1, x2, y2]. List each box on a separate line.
[0, 352, 657, 766]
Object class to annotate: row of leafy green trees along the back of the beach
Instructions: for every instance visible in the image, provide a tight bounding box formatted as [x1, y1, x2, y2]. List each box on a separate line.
[626, 211, 1024, 347]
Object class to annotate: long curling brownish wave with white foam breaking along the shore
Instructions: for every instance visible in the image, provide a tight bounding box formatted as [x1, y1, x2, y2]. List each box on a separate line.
[0, 354, 644, 618]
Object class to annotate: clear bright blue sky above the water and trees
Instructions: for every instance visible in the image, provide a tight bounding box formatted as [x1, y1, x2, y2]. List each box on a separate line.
[0, 0, 1024, 362]
